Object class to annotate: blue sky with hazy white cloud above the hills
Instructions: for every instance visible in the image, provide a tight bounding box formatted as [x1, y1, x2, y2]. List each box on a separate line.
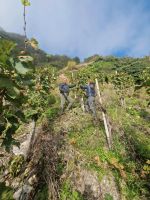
[0, 0, 150, 59]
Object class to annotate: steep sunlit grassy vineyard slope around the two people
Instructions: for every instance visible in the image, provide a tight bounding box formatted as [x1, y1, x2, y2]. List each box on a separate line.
[0, 38, 150, 200]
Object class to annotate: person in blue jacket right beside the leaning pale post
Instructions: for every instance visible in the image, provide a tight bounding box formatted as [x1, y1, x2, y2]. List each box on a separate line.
[80, 81, 97, 119]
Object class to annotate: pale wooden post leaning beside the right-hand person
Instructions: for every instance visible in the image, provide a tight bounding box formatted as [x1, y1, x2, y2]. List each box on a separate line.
[95, 78, 112, 149]
